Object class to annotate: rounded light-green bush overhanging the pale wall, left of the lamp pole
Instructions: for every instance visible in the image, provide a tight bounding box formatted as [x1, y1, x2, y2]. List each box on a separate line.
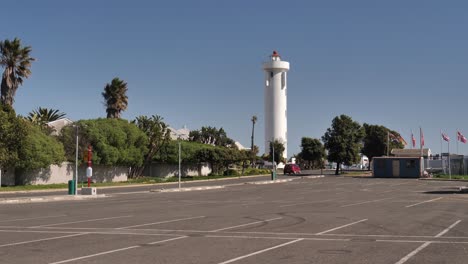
[15, 124, 65, 171]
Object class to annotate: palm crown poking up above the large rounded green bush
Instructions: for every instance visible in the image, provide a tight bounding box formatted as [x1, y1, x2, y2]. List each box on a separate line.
[102, 77, 128, 118]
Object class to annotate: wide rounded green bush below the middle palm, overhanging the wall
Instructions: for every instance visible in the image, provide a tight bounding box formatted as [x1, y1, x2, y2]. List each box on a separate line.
[59, 118, 148, 166]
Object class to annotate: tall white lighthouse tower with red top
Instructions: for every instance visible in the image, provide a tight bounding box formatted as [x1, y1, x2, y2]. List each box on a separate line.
[263, 51, 289, 158]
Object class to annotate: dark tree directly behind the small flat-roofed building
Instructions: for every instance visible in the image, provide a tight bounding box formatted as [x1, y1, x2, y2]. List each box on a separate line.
[362, 123, 404, 169]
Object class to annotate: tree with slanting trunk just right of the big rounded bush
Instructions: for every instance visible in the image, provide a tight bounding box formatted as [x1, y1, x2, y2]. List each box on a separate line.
[130, 115, 171, 177]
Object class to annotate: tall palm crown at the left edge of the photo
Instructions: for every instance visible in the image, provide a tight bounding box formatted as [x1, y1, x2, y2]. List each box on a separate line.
[0, 38, 35, 106]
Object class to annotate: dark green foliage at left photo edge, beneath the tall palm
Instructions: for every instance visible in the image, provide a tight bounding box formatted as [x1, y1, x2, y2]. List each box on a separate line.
[0, 104, 27, 169]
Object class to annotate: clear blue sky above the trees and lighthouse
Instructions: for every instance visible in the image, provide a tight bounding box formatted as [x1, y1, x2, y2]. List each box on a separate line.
[0, 0, 468, 156]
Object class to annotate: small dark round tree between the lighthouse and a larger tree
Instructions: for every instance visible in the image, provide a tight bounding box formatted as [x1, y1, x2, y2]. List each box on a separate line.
[299, 137, 325, 168]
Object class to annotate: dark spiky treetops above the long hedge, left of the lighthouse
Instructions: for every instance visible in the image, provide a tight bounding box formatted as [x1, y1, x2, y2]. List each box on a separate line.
[189, 126, 236, 148]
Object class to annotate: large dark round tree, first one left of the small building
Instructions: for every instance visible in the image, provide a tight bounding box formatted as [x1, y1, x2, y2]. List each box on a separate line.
[322, 115, 365, 175]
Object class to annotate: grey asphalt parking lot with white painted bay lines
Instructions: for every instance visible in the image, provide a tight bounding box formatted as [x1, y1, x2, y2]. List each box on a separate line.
[0, 176, 468, 264]
